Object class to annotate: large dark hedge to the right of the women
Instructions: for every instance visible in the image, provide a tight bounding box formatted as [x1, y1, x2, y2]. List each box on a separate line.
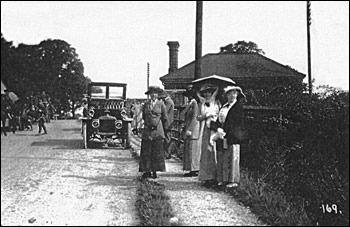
[241, 86, 349, 225]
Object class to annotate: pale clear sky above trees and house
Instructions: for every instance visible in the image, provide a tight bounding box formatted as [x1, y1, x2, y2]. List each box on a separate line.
[1, 1, 349, 98]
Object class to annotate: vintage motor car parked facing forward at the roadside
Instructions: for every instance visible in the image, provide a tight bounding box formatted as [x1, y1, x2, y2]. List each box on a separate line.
[81, 82, 132, 149]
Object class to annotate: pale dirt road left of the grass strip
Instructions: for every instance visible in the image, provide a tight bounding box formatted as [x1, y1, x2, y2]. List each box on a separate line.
[1, 120, 139, 226]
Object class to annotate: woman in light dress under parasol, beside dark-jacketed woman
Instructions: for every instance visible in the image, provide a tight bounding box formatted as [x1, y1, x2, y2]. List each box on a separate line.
[197, 84, 220, 187]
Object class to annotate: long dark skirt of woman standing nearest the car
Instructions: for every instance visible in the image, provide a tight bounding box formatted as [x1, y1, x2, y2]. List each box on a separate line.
[139, 139, 165, 172]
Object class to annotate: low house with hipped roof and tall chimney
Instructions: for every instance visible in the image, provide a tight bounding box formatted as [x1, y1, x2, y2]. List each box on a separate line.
[160, 41, 305, 105]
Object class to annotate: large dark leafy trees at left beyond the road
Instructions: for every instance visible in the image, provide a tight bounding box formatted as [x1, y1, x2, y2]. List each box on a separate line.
[1, 33, 90, 111]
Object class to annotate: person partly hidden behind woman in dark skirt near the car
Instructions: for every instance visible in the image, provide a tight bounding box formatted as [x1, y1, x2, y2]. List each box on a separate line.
[160, 91, 174, 159]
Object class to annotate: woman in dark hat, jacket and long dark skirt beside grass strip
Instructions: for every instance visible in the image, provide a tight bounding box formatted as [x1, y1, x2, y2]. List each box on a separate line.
[139, 86, 169, 178]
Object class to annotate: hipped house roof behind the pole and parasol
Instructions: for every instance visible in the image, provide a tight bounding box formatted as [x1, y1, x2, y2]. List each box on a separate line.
[160, 53, 305, 82]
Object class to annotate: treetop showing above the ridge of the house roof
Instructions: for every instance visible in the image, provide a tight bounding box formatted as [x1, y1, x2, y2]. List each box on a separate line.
[220, 41, 265, 54]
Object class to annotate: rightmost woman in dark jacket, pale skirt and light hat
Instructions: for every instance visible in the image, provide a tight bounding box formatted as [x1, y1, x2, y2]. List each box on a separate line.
[212, 86, 245, 188]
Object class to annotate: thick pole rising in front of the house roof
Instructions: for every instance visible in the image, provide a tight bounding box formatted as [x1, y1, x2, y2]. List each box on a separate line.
[194, 1, 203, 79]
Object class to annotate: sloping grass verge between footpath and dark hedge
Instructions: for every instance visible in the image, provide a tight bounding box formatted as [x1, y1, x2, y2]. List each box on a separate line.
[228, 170, 311, 226]
